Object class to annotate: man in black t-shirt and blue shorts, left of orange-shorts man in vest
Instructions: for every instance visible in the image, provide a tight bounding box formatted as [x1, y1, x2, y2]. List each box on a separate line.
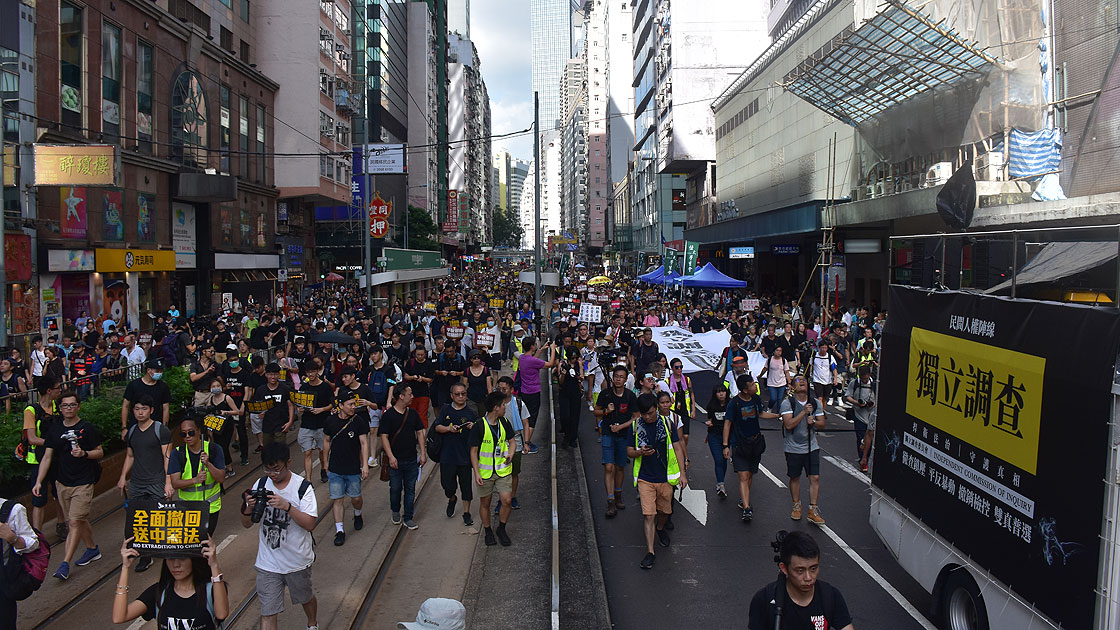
[595, 365, 638, 518]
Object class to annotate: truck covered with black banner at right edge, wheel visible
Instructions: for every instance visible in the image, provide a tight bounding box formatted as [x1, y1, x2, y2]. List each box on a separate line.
[869, 228, 1120, 630]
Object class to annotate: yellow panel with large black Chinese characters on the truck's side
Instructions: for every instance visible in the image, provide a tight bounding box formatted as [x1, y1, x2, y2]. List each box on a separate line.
[906, 328, 1046, 474]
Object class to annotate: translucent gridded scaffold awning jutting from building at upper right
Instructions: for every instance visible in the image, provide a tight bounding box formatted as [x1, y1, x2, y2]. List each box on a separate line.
[782, 0, 997, 127]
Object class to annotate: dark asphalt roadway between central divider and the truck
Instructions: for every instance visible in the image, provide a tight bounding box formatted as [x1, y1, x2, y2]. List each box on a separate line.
[580, 372, 931, 630]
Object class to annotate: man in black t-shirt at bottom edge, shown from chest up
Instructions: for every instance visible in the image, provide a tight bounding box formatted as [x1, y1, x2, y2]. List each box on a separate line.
[747, 531, 855, 630]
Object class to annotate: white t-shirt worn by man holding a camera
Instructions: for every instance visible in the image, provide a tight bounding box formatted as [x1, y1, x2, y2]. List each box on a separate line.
[253, 473, 319, 574]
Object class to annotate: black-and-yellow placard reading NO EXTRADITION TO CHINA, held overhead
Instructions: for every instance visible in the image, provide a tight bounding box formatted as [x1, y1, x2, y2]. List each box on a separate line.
[124, 499, 209, 557]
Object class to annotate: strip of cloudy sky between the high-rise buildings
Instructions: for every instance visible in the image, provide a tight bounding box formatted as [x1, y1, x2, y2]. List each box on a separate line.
[470, 0, 533, 161]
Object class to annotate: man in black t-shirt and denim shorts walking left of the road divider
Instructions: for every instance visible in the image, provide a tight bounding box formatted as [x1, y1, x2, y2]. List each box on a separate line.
[324, 390, 370, 547]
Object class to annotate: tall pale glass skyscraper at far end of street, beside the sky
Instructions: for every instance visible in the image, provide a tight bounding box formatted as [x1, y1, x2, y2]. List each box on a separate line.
[530, 0, 571, 130]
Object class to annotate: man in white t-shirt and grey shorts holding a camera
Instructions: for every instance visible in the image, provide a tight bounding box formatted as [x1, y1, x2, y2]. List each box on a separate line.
[241, 441, 319, 630]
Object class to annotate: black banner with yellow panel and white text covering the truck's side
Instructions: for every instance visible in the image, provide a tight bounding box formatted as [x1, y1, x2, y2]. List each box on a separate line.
[871, 286, 1120, 628]
